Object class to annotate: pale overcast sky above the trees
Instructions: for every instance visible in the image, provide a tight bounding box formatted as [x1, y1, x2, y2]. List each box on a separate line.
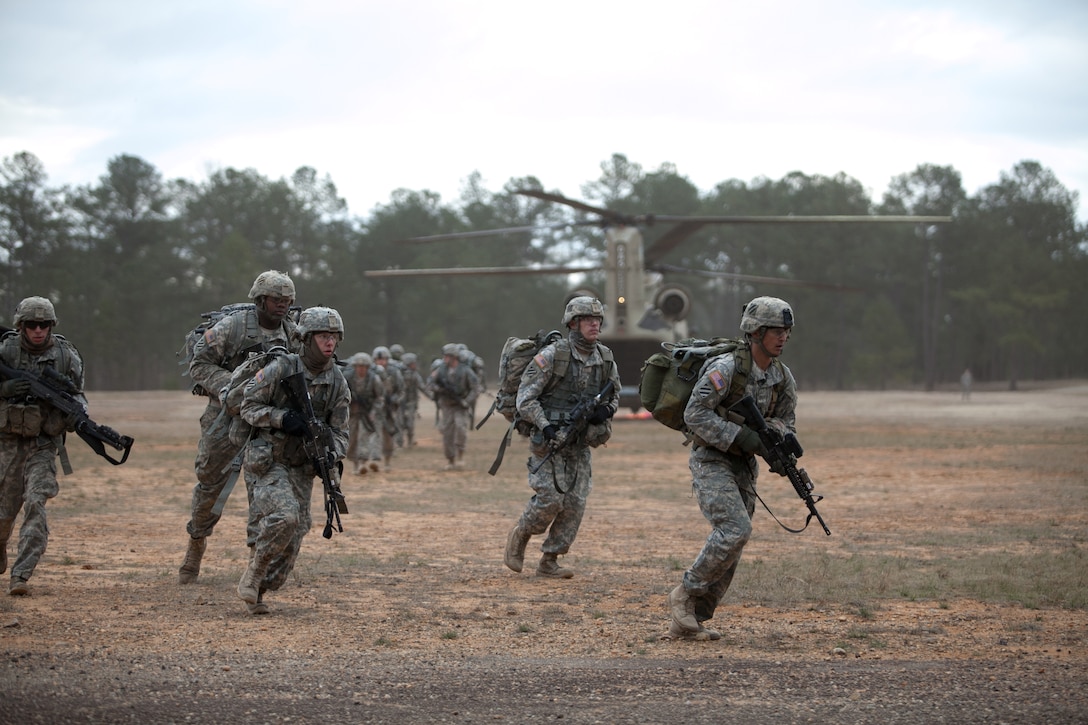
[0, 0, 1088, 221]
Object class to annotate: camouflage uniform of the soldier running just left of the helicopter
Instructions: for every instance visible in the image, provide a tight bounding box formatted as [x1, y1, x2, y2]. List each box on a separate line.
[507, 324, 620, 577]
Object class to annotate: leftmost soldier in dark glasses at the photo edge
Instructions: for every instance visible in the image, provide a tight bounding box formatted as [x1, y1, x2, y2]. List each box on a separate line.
[0, 297, 87, 597]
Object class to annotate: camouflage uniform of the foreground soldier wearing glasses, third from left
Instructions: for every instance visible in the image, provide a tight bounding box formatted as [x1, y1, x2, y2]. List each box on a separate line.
[239, 324, 351, 602]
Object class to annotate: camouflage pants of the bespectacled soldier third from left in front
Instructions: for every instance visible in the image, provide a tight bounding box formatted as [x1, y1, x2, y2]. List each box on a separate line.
[244, 440, 313, 591]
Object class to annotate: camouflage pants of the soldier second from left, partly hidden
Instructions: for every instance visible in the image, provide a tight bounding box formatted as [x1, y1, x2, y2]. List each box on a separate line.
[185, 405, 257, 545]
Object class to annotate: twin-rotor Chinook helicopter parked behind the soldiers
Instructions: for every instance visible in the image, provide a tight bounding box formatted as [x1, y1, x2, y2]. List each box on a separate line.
[364, 188, 952, 410]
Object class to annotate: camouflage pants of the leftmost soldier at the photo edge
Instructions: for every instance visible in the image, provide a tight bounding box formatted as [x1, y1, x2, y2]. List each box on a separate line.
[0, 435, 60, 579]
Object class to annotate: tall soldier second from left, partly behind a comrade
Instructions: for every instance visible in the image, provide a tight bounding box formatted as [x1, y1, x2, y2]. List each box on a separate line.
[177, 270, 297, 585]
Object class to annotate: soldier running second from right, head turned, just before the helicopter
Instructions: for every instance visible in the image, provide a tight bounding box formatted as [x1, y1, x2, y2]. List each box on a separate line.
[504, 297, 620, 579]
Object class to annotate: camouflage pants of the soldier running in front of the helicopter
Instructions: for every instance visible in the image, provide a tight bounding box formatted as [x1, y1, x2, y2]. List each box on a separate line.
[518, 445, 593, 554]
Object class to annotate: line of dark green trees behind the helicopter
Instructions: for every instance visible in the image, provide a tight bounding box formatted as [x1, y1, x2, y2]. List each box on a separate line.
[0, 152, 1088, 390]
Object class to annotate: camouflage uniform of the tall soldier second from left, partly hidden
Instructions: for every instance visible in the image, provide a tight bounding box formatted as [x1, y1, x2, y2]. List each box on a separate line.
[185, 309, 297, 545]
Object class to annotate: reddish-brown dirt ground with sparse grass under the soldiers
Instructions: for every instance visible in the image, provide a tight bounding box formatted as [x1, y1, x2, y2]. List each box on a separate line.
[0, 383, 1088, 723]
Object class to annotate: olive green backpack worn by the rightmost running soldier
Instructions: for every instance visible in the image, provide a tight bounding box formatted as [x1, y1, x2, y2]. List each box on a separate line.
[639, 337, 765, 432]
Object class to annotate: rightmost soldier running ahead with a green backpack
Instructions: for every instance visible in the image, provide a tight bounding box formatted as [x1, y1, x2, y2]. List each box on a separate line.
[667, 297, 798, 640]
